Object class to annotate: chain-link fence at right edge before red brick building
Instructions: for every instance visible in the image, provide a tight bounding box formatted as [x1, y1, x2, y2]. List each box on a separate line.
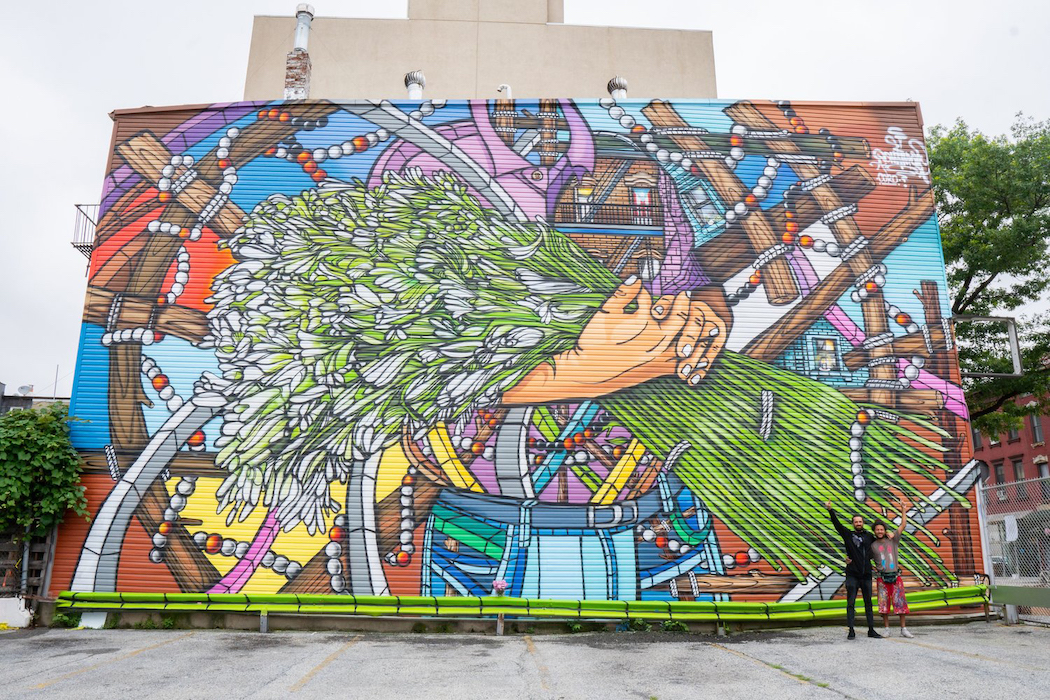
[979, 478, 1050, 624]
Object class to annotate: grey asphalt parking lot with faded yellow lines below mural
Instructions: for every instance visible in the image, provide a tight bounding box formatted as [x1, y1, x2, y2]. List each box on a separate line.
[0, 622, 1050, 700]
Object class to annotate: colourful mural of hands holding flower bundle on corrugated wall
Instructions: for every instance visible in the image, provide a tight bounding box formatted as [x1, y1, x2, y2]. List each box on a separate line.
[53, 99, 980, 600]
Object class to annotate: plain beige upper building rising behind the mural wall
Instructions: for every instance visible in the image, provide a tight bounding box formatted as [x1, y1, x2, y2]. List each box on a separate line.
[245, 0, 716, 100]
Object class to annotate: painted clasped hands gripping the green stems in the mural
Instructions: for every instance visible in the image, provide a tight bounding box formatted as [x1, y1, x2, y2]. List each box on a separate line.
[504, 277, 732, 403]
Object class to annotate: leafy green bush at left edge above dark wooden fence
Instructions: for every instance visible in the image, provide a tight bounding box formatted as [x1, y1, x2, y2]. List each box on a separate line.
[0, 403, 87, 537]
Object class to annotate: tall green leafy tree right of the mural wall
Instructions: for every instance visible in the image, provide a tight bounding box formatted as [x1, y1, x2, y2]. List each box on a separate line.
[927, 114, 1050, 434]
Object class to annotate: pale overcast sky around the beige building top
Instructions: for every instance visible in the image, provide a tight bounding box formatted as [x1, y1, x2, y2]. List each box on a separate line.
[0, 0, 1050, 396]
